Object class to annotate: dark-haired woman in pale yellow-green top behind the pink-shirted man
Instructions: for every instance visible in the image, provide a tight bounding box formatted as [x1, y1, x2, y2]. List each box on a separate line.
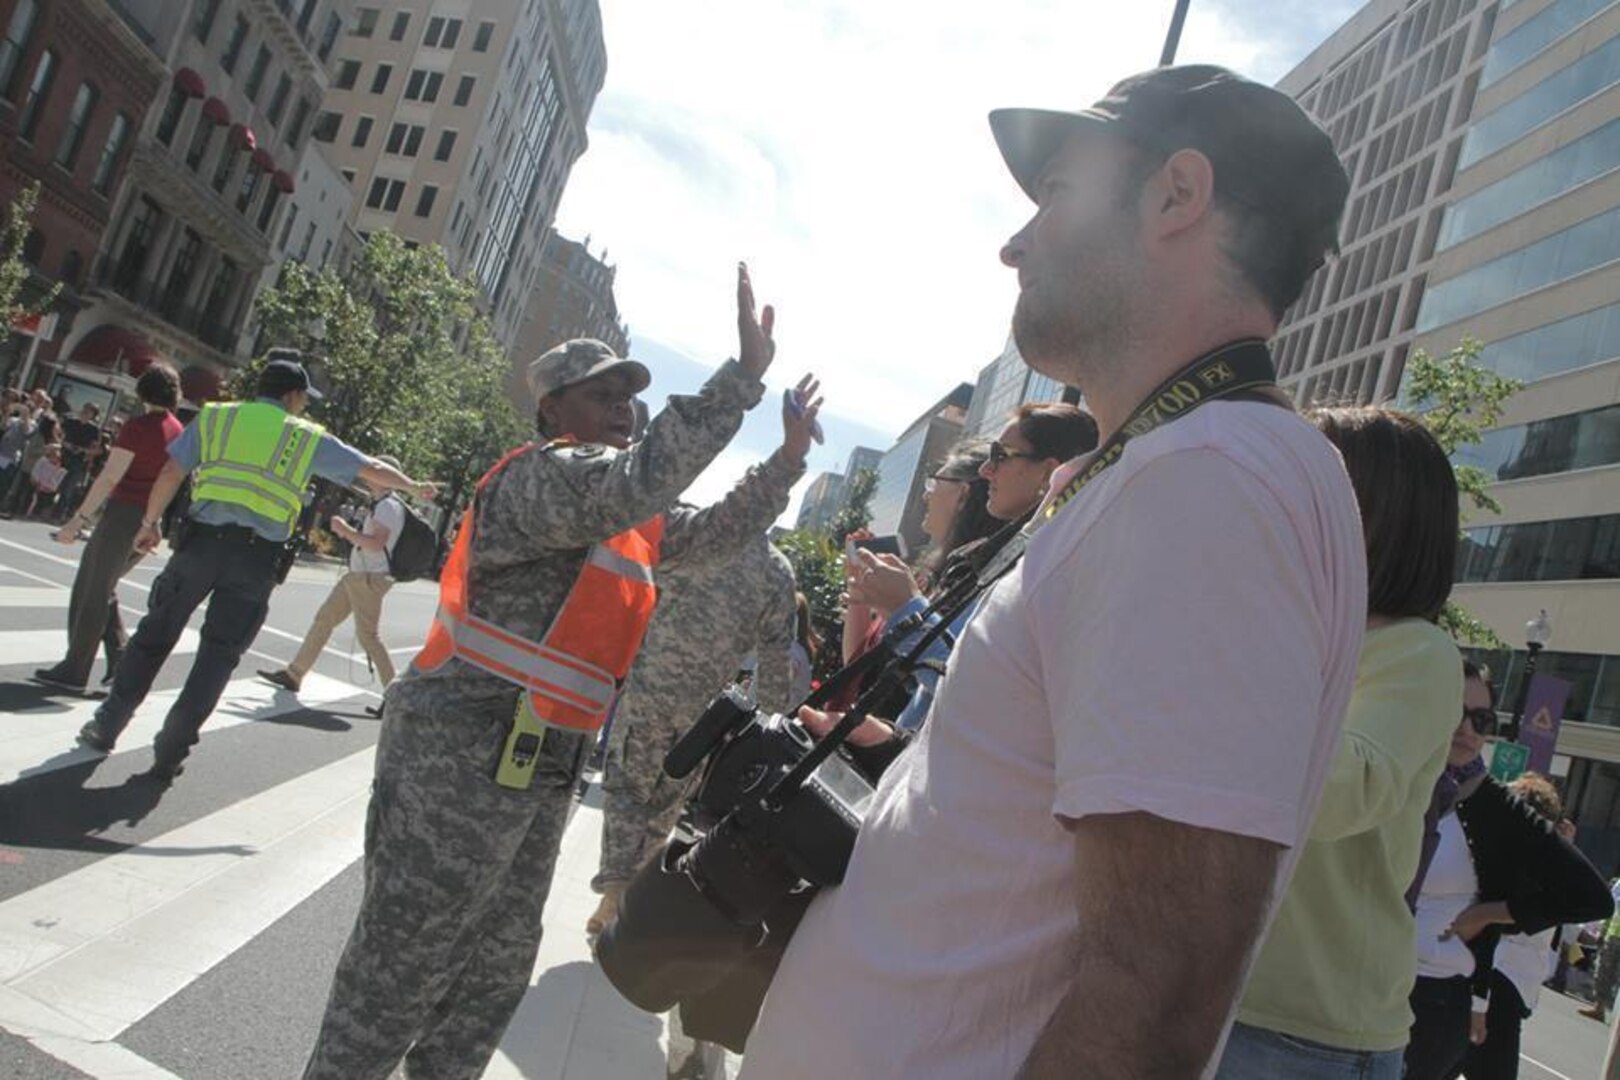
[1217, 408, 1463, 1080]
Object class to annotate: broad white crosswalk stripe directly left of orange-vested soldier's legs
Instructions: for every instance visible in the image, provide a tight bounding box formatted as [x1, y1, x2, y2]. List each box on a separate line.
[0, 748, 376, 1042]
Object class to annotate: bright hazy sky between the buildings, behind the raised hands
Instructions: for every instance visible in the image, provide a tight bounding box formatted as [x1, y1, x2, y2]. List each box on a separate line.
[557, 0, 1361, 518]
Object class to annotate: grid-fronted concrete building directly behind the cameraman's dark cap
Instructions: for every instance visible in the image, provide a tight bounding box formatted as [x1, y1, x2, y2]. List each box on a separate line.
[1273, 0, 1490, 403]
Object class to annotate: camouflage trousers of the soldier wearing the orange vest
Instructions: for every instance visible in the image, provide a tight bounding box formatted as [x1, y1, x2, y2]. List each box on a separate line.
[305, 683, 585, 1080]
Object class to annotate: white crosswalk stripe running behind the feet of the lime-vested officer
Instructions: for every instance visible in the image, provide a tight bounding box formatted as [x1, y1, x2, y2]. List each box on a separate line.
[0, 672, 366, 784]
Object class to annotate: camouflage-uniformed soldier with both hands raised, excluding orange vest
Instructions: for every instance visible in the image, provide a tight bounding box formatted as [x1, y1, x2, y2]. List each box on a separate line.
[305, 267, 816, 1080]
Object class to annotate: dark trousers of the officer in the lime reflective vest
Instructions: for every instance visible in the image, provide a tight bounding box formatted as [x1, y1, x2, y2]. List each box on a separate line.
[86, 523, 282, 766]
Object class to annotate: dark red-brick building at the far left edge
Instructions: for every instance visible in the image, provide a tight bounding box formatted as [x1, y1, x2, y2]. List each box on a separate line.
[0, 0, 167, 384]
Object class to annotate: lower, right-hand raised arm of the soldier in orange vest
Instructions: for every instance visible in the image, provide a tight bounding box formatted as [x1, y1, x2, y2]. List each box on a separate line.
[664, 376, 821, 560]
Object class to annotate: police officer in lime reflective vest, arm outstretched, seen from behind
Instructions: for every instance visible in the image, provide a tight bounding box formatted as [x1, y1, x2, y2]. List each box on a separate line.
[79, 348, 434, 785]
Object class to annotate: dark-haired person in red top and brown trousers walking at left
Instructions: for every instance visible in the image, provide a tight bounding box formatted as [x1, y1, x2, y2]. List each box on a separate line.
[34, 364, 181, 693]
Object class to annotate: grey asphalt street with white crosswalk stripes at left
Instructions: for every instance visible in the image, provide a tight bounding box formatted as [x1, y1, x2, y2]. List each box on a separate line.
[0, 521, 1604, 1080]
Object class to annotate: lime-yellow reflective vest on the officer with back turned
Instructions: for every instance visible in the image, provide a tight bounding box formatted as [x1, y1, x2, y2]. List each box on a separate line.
[191, 402, 322, 531]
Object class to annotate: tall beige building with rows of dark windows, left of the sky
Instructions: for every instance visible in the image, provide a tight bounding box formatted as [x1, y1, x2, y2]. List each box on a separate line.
[314, 0, 608, 348]
